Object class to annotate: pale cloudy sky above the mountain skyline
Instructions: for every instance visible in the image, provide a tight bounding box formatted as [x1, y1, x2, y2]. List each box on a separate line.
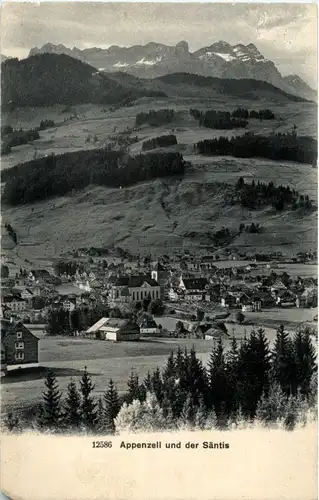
[1, 1, 317, 88]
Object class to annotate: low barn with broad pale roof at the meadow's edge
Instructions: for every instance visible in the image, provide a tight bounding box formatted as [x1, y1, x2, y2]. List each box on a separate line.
[86, 318, 140, 342]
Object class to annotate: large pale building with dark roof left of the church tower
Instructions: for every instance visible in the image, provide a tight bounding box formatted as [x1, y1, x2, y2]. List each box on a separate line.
[109, 275, 161, 303]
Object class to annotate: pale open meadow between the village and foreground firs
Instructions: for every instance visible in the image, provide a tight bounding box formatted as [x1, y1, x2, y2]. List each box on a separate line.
[2, 309, 317, 416]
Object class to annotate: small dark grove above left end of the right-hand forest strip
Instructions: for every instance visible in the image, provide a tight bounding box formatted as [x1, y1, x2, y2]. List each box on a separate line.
[190, 109, 248, 130]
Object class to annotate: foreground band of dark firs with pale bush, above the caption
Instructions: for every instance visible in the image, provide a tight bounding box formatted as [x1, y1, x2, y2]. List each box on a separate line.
[6, 326, 317, 433]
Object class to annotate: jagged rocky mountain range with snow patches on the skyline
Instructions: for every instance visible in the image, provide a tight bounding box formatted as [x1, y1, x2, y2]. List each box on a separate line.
[29, 41, 317, 100]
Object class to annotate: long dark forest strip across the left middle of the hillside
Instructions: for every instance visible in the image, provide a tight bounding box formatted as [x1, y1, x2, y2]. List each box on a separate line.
[1, 149, 185, 205]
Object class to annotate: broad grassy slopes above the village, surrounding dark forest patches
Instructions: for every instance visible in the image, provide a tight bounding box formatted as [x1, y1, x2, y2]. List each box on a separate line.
[2, 98, 317, 260]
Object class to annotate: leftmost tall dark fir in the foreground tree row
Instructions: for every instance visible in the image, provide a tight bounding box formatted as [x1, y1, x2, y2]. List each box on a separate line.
[38, 371, 62, 430]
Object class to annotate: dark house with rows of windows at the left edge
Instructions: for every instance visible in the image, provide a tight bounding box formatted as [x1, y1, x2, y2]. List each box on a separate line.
[1, 319, 39, 369]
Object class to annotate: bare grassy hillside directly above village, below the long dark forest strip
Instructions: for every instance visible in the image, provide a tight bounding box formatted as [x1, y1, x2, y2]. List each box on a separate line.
[2, 157, 316, 266]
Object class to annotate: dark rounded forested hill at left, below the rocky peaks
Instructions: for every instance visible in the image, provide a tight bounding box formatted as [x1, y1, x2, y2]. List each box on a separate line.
[1, 54, 163, 109]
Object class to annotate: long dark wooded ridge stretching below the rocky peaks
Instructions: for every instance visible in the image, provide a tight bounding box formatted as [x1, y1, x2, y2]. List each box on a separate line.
[1, 53, 305, 110]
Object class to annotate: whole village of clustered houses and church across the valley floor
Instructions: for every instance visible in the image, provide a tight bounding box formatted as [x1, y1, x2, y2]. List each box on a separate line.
[1, 248, 318, 374]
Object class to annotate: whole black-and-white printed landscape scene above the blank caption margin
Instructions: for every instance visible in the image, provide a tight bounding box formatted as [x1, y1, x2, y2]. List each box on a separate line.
[1, 2, 318, 500]
